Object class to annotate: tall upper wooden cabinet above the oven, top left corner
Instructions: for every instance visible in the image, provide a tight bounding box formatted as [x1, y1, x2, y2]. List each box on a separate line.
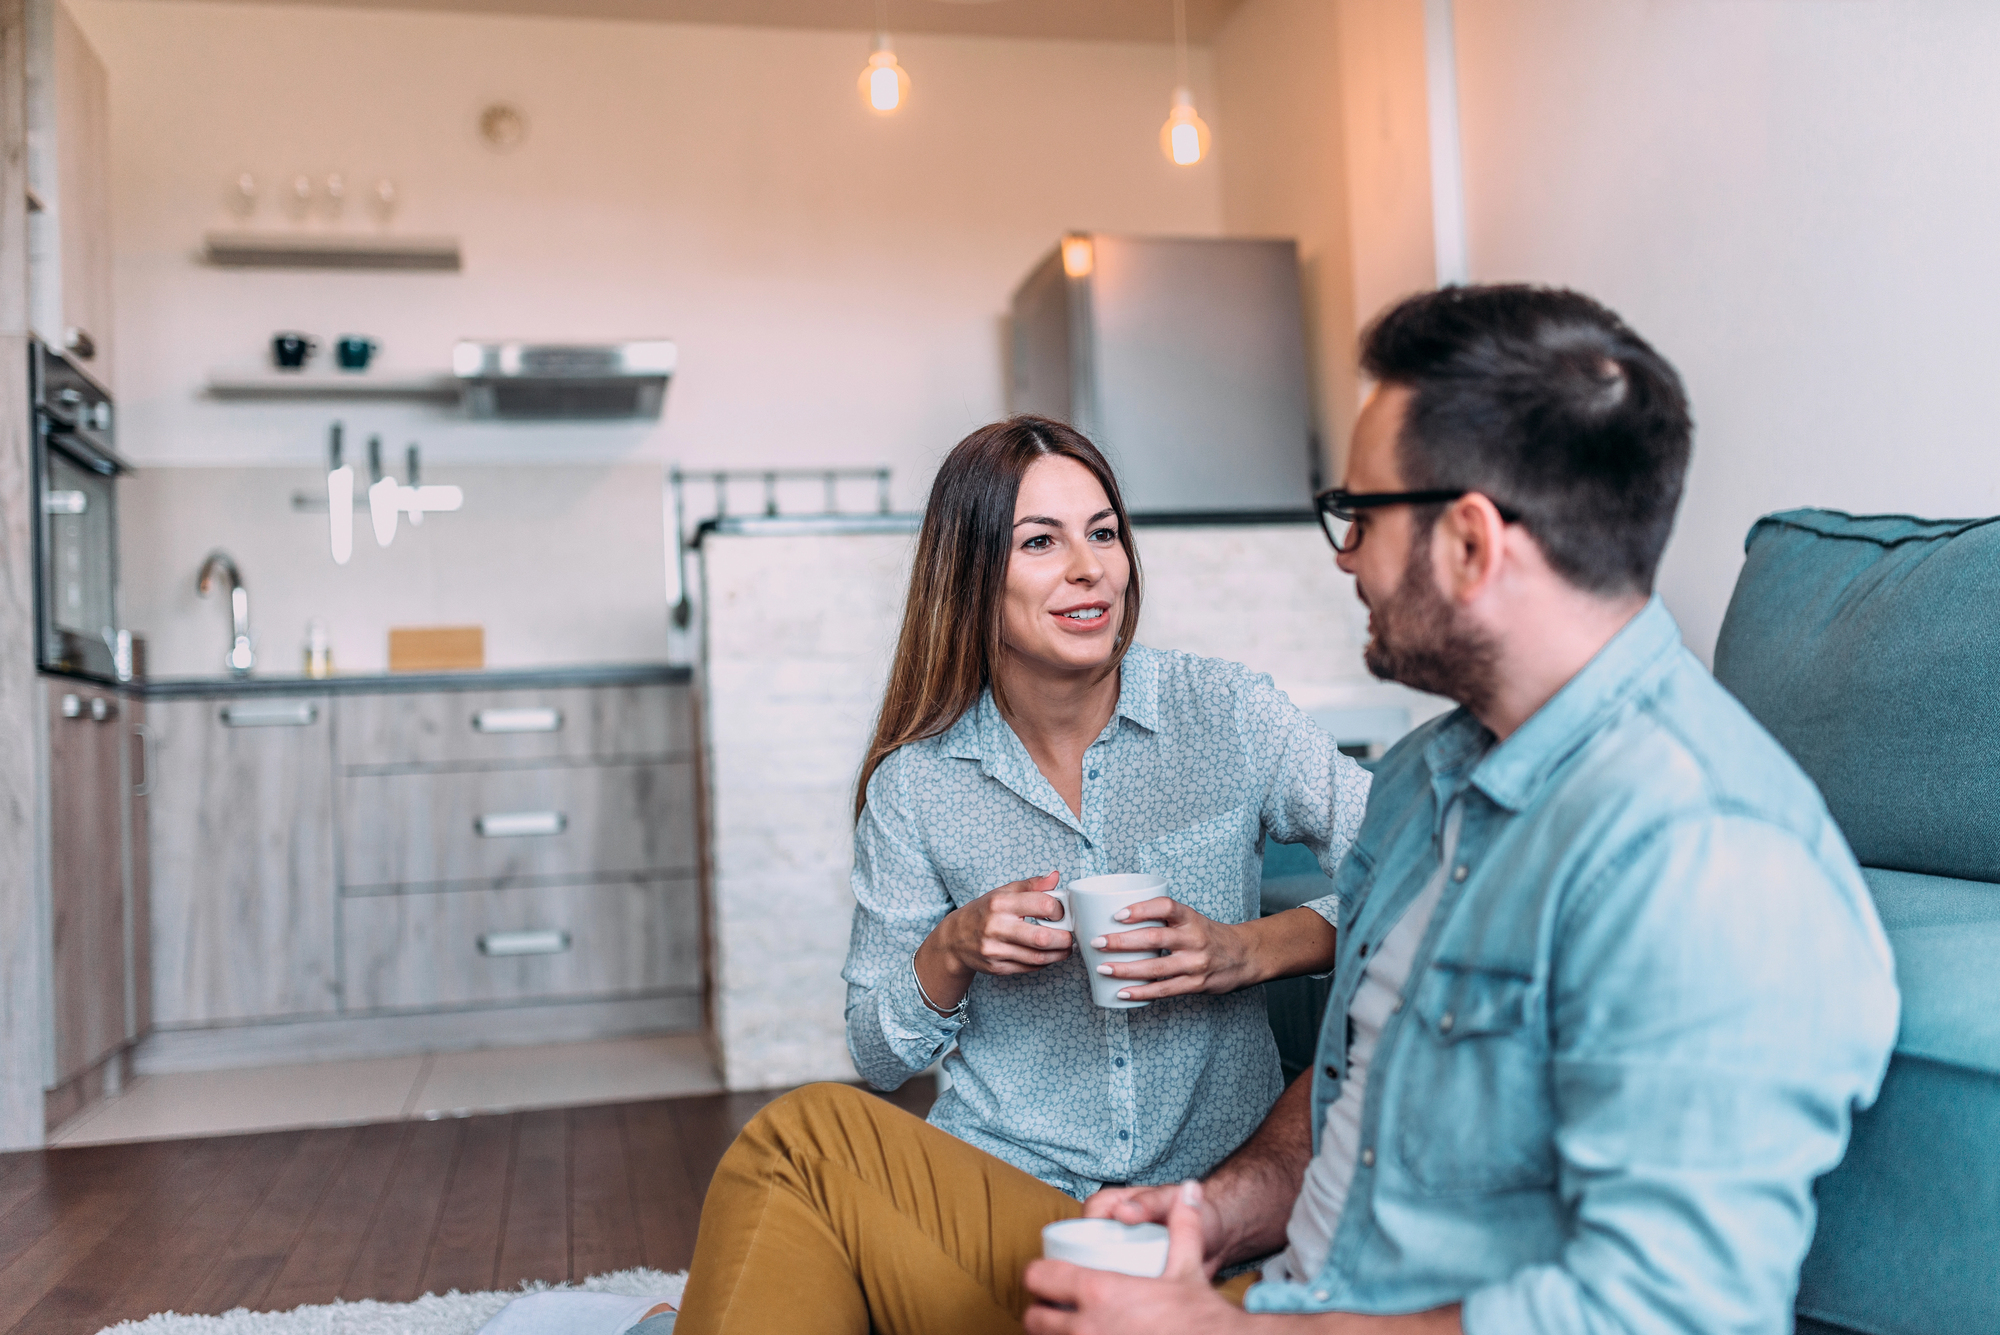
[26, 0, 112, 386]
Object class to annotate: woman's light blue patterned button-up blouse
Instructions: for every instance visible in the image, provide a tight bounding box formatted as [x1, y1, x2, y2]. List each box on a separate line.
[842, 646, 1368, 1197]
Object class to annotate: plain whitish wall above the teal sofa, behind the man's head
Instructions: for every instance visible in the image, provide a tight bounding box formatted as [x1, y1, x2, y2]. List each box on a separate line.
[1458, 0, 2000, 654]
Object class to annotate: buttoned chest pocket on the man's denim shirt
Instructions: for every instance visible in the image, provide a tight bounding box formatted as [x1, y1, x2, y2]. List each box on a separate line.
[1396, 963, 1556, 1195]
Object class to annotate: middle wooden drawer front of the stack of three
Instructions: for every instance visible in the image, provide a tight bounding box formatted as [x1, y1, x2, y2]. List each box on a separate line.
[340, 761, 696, 893]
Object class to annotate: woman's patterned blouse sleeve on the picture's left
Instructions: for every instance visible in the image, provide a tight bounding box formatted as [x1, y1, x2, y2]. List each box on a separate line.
[840, 755, 964, 1089]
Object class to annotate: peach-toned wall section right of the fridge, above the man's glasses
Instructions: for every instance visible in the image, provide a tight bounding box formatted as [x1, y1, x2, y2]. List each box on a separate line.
[1214, 0, 1434, 470]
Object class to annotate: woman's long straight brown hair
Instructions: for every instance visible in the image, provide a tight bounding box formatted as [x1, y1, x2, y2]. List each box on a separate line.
[854, 418, 1138, 819]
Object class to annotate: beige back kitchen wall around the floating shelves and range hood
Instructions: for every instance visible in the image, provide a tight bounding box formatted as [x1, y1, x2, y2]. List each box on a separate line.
[68, 0, 1222, 489]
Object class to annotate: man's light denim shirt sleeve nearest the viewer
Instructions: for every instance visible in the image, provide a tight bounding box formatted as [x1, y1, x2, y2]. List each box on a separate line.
[1464, 819, 1898, 1335]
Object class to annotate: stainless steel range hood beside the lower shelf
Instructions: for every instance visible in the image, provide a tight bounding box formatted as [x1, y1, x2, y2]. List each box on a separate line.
[452, 338, 676, 422]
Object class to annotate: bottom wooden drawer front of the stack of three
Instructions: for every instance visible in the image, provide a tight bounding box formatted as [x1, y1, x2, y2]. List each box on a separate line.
[340, 879, 702, 1011]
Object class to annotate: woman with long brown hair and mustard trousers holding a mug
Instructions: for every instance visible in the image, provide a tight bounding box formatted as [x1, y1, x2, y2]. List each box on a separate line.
[504, 418, 1368, 1335]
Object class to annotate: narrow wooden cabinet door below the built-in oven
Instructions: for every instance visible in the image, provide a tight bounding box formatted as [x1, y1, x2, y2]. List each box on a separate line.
[46, 681, 128, 1083]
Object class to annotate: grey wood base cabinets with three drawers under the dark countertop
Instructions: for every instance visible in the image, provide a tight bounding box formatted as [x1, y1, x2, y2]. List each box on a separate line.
[140, 668, 704, 1069]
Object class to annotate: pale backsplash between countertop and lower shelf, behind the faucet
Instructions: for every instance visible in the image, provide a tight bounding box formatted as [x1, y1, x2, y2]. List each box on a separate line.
[120, 464, 668, 677]
